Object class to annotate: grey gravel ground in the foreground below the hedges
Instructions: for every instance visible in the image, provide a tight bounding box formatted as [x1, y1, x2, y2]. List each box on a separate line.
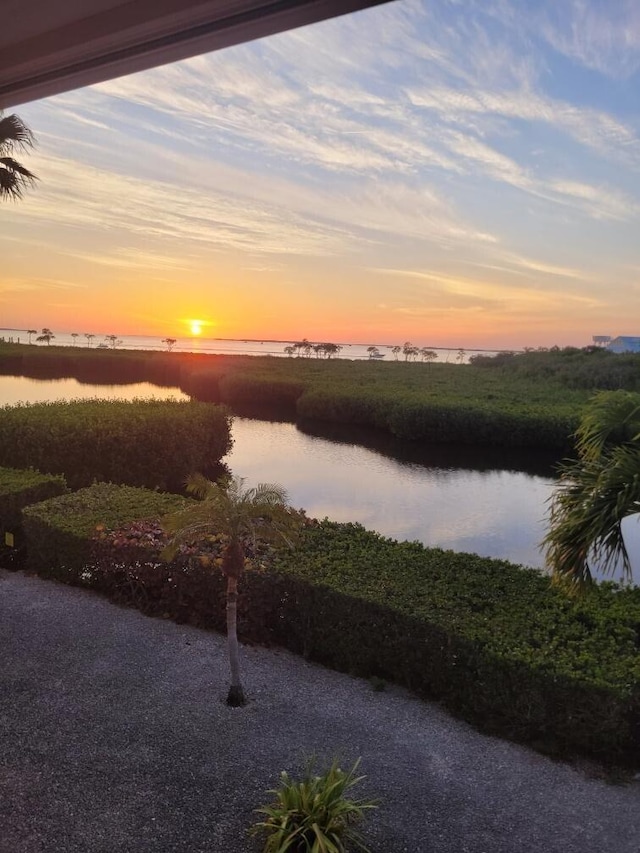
[0, 572, 640, 853]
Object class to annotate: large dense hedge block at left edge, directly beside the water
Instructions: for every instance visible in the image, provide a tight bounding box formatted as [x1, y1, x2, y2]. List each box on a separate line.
[0, 400, 231, 490]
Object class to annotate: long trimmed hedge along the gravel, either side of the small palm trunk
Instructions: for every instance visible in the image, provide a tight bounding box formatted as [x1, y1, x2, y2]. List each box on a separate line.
[31, 498, 640, 766]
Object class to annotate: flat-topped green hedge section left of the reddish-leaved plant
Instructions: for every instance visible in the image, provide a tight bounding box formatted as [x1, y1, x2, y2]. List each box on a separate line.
[22, 483, 192, 583]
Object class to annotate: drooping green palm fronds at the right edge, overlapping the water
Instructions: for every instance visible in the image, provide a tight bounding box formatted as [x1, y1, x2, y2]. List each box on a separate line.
[543, 391, 640, 593]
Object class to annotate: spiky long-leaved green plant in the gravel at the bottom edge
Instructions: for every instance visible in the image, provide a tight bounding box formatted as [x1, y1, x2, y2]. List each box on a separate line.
[251, 759, 377, 853]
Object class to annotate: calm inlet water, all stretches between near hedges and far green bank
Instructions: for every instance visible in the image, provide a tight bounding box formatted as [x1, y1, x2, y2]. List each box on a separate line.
[0, 376, 640, 580]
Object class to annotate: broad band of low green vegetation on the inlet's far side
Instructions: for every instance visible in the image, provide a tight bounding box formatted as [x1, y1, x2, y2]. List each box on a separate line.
[0, 344, 640, 452]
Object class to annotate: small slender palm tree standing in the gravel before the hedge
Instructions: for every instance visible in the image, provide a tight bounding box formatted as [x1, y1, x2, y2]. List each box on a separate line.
[164, 474, 301, 707]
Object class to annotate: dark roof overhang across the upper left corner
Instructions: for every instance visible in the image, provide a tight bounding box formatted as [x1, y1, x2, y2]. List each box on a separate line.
[0, 0, 388, 109]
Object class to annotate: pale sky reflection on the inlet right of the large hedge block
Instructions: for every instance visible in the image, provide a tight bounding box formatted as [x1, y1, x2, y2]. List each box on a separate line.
[227, 418, 553, 566]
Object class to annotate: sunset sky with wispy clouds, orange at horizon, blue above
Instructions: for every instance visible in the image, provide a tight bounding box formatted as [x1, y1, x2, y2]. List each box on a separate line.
[0, 0, 640, 349]
